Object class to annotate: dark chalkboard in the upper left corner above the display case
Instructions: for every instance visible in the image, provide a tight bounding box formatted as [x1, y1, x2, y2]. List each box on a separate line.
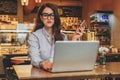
[0, 0, 17, 15]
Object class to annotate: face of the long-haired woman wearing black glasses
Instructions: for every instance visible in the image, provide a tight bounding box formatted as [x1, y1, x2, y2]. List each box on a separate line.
[40, 7, 54, 28]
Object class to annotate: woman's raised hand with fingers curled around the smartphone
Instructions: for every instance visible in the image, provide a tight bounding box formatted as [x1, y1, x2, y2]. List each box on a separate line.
[72, 26, 85, 40]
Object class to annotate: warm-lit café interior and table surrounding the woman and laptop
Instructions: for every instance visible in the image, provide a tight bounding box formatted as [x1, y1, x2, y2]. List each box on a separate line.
[0, 0, 120, 80]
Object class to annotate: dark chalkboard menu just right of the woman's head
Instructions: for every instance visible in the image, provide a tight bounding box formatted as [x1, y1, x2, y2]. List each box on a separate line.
[58, 6, 82, 18]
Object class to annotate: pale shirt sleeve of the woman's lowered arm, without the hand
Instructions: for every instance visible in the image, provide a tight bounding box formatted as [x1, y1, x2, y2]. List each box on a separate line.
[28, 34, 42, 68]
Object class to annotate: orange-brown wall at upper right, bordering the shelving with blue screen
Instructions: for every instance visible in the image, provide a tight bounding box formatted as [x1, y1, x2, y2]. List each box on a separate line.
[83, 0, 120, 48]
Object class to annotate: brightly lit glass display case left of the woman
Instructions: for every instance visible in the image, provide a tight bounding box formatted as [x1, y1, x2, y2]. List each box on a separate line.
[0, 24, 34, 54]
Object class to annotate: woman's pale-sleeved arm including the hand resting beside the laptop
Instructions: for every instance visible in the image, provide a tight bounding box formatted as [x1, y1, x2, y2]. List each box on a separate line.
[28, 34, 52, 71]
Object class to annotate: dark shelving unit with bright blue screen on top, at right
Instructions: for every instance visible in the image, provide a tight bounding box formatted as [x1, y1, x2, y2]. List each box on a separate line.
[90, 12, 111, 45]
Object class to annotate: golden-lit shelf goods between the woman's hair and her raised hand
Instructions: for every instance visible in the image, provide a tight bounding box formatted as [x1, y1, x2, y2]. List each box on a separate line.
[60, 17, 82, 40]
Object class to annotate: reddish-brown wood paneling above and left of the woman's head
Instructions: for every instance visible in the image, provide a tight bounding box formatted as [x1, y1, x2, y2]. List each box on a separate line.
[24, 0, 82, 22]
